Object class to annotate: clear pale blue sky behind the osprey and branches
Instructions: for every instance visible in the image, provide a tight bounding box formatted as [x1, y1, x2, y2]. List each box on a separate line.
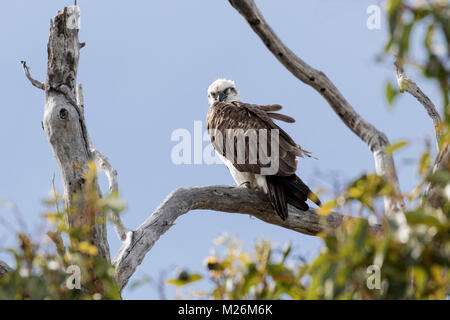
[0, 0, 441, 299]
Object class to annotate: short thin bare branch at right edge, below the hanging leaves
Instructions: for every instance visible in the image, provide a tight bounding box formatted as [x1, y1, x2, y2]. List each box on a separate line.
[395, 61, 442, 151]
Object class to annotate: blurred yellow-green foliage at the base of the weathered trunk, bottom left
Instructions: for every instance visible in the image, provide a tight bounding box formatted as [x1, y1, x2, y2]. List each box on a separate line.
[0, 164, 123, 299]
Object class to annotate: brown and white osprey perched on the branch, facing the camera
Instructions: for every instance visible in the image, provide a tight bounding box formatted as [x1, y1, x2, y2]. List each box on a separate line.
[206, 79, 320, 220]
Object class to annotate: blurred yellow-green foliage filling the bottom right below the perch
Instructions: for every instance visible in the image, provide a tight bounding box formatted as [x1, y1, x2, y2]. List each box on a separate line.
[170, 148, 450, 299]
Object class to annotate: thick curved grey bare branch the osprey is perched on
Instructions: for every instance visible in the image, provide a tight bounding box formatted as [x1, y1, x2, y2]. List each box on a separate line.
[113, 186, 380, 288]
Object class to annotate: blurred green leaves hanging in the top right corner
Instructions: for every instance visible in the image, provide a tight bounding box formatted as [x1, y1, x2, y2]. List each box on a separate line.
[385, 0, 450, 109]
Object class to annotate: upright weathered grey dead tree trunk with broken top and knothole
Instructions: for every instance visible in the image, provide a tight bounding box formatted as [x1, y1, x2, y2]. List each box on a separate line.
[43, 6, 110, 260]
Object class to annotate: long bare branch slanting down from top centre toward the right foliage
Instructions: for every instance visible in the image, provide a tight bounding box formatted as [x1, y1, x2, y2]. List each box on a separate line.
[229, 0, 404, 213]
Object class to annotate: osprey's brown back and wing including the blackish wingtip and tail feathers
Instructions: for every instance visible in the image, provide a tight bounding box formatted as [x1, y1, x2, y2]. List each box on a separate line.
[206, 102, 320, 220]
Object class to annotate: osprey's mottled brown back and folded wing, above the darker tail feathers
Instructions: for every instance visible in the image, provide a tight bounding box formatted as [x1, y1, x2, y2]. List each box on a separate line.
[207, 102, 309, 176]
